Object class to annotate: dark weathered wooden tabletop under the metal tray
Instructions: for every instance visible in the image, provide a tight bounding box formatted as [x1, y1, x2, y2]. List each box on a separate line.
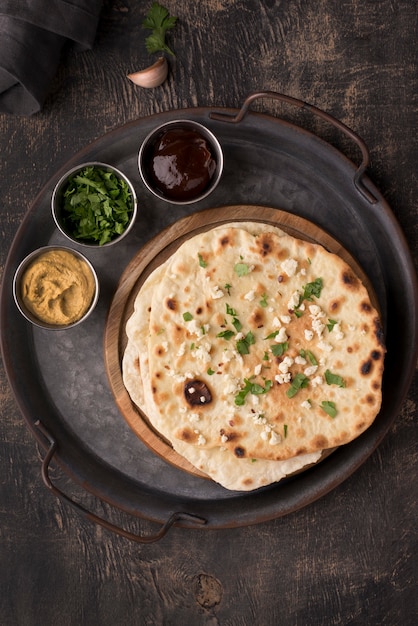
[0, 0, 418, 626]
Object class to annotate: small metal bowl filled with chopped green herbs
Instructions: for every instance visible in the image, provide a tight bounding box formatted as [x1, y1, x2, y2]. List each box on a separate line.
[51, 161, 137, 247]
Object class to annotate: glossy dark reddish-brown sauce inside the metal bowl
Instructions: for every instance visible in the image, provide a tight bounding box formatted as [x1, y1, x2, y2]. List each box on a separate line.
[149, 128, 216, 201]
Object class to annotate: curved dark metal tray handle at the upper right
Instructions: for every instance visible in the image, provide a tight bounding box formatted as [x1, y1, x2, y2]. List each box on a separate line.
[209, 91, 378, 204]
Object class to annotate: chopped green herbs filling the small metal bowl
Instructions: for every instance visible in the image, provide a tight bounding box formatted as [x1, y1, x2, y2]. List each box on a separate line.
[62, 165, 133, 245]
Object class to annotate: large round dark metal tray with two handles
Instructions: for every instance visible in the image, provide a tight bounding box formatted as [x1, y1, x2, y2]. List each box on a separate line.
[0, 92, 418, 542]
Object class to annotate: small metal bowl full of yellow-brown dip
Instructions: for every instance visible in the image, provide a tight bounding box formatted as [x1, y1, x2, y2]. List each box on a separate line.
[13, 246, 99, 330]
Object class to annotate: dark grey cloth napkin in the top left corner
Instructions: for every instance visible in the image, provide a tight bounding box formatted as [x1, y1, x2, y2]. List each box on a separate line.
[0, 0, 103, 115]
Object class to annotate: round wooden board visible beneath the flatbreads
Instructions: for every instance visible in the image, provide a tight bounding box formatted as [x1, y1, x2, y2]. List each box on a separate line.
[104, 205, 377, 478]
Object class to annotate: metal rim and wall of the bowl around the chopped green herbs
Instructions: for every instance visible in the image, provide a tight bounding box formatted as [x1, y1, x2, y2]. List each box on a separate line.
[51, 161, 138, 248]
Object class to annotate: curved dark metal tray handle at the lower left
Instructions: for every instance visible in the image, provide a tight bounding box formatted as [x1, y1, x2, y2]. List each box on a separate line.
[35, 420, 207, 543]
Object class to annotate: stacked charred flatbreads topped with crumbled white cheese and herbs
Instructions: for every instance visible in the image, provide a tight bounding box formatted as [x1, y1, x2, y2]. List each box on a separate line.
[122, 222, 385, 491]
